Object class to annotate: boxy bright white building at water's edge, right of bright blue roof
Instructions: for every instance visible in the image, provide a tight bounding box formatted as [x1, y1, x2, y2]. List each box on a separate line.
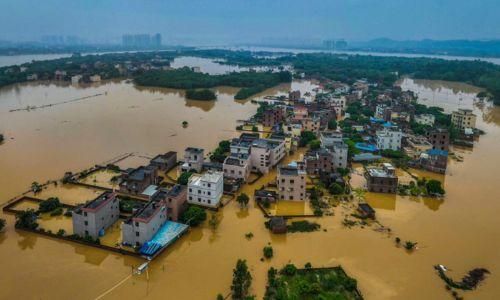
[187, 171, 224, 207]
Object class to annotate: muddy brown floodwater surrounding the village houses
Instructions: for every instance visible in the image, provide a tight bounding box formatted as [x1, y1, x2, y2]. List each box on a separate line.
[0, 79, 500, 299]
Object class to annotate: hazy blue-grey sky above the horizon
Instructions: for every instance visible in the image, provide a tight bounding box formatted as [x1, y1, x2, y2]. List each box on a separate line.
[0, 0, 500, 43]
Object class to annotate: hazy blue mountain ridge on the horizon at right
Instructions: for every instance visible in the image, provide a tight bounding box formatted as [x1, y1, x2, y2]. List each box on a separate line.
[348, 38, 500, 57]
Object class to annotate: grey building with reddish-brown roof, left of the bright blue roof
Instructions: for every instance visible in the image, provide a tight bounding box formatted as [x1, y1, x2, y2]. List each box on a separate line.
[72, 192, 120, 238]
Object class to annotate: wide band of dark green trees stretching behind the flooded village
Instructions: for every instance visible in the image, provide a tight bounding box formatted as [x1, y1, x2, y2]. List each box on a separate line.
[0, 49, 500, 105]
